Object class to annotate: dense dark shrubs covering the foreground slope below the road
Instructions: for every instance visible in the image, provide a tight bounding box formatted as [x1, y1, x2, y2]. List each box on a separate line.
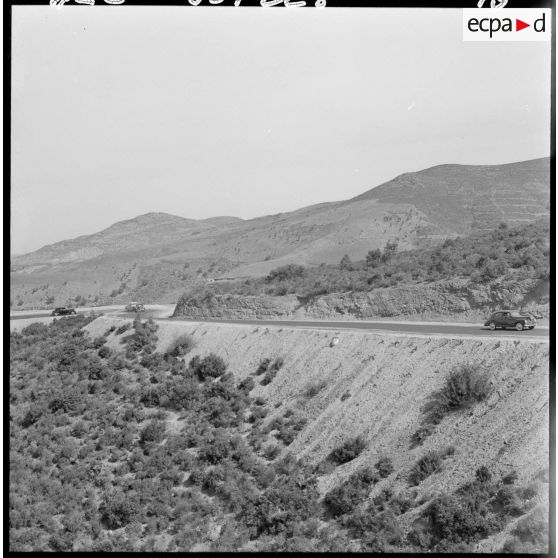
[9, 316, 547, 552]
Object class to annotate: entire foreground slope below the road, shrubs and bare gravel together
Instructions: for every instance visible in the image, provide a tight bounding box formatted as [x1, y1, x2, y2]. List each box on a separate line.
[9, 317, 549, 553]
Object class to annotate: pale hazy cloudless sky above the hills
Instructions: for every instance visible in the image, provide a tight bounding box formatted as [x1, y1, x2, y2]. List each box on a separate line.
[11, 5, 550, 253]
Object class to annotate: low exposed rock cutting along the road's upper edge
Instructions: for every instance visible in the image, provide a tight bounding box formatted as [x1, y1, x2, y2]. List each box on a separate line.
[174, 279, 549, 320]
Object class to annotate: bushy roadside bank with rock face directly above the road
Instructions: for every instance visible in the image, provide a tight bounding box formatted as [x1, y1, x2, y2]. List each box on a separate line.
[174, 219, 550, 321]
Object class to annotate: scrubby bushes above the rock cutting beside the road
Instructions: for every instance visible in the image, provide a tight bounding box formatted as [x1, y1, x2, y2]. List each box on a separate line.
[179, 219, 550, 305]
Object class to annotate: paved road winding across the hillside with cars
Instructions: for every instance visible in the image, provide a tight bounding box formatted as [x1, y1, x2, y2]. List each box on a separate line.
[10, 309, 549, 339]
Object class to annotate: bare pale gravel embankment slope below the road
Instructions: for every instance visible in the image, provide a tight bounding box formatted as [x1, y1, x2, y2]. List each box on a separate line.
[87, 318, 549, 552]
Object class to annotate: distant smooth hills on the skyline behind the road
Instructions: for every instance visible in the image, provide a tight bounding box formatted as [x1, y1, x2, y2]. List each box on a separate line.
[11, 158, 550, 309]
